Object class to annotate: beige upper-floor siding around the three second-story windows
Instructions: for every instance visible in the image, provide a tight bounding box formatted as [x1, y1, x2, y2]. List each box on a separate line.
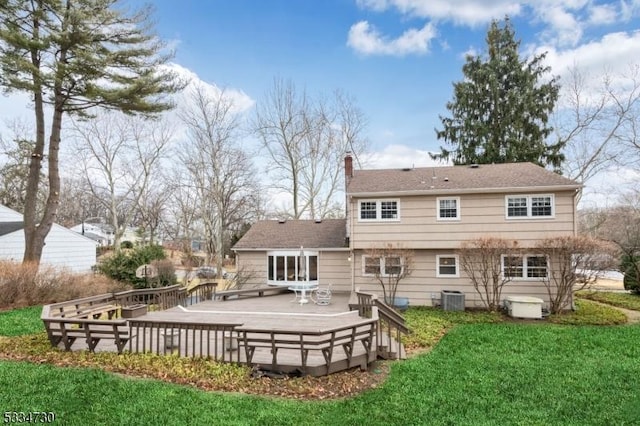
[350, 191, 575, 249]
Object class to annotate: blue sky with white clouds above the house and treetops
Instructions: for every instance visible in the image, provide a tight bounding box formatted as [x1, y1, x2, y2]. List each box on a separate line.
[139, 0, 640, 161]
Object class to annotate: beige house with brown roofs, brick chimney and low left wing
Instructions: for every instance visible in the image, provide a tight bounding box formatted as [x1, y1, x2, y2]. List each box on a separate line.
[234, 156, 581, 307]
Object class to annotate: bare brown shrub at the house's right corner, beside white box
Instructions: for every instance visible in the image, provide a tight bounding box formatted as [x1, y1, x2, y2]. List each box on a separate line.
[536, 236, 618, 313]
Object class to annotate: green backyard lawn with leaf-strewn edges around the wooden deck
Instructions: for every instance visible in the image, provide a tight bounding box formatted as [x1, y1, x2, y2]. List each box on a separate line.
[0, 300, 640, 425]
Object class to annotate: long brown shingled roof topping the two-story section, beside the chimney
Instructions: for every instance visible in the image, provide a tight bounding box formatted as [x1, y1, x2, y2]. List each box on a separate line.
[347, 163, 581, 195]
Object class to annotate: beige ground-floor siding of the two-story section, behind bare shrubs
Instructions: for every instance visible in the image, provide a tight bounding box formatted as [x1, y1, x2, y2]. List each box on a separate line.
[354, 250, 549, 308]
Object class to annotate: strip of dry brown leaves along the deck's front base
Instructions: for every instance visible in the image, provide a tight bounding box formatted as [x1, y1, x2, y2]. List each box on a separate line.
[0, 333, 389, 400]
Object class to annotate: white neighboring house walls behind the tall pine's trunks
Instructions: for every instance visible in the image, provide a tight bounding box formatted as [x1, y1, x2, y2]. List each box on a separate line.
[0, 205, 96, 272]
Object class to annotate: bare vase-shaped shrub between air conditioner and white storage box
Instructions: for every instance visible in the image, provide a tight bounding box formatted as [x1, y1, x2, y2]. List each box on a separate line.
[458, 237, 520, 311]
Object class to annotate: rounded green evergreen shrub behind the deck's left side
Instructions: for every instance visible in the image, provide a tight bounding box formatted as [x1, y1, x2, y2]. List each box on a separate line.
[98, 245, 175, 288]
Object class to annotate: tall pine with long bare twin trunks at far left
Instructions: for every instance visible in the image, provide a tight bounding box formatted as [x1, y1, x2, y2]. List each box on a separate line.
[0, 0, 181, 262]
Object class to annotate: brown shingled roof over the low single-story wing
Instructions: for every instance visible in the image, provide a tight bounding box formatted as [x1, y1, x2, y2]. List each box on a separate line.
[233, 219, 347, 250]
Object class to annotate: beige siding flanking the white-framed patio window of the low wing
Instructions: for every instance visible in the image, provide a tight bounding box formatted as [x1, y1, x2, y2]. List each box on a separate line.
[237, 249, 351, 291]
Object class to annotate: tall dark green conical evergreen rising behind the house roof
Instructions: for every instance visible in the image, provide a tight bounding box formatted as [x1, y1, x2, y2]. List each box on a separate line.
[432, 18, 564, 170]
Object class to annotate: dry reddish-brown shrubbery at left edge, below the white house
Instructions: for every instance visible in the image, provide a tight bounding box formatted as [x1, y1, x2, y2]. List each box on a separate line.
[0, 261, 128, 308]
